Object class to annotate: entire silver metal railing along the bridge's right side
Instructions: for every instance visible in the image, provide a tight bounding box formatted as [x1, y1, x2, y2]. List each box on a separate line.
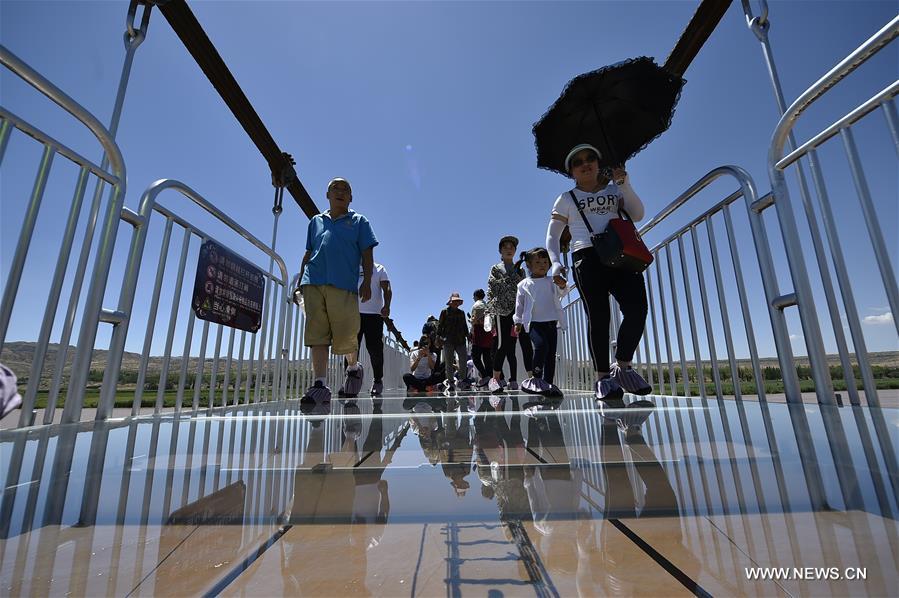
[557, 17, 899, 406]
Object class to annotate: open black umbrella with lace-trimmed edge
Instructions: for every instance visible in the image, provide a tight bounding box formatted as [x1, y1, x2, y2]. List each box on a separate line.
[533, 56, 685, 174]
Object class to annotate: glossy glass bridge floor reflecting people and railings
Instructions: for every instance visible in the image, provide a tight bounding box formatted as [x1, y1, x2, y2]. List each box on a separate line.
[0, 393, 899, 596]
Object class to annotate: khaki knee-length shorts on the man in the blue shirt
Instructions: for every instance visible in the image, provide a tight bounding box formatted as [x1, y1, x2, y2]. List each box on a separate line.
[303, 284, 359, 355]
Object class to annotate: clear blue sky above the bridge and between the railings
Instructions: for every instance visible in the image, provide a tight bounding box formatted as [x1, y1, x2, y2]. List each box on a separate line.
[0, 0, 899, 366]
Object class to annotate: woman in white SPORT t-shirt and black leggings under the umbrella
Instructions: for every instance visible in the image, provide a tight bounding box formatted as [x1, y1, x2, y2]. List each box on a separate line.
[546, 144, 652, 400]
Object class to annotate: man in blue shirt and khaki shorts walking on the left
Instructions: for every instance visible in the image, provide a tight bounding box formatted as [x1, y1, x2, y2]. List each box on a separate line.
[296, 178, 378, 414]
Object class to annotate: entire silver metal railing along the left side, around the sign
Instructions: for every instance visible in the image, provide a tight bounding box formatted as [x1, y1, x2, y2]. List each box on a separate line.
[0, 48, 408, 427]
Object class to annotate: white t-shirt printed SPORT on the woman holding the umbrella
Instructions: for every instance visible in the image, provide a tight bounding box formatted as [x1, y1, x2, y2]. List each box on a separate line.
[552, 182, 643, 252]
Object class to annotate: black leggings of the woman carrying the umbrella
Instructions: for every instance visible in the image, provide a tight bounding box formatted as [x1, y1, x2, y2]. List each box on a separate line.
[572, 247, 649, 372]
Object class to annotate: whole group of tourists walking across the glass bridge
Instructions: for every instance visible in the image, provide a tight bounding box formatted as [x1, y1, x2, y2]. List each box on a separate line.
[296, 144, 652, 408]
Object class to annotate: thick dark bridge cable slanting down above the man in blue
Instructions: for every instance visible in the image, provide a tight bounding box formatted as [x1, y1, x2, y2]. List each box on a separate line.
[153, 0, 319, 218]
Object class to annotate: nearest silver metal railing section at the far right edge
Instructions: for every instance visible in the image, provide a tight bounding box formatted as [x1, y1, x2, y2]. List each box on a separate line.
[768, 17, 899, 406]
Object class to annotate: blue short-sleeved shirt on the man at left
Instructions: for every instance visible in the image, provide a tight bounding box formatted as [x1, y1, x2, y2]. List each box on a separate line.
[300, 210, 378, 293]
